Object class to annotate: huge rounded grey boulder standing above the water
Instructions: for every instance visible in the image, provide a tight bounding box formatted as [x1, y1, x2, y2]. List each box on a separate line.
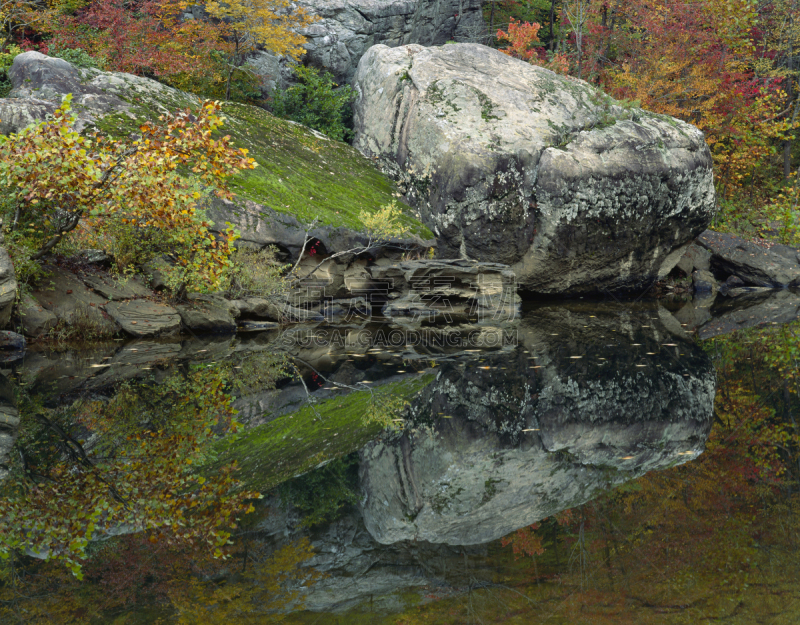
[353, 44, 715, 293]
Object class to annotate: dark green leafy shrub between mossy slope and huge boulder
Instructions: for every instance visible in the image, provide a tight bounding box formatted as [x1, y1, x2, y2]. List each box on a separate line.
[272, 65, 355, 141]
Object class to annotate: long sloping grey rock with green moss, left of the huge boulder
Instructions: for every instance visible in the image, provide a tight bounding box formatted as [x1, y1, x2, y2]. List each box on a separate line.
[0, 52, 431, 245]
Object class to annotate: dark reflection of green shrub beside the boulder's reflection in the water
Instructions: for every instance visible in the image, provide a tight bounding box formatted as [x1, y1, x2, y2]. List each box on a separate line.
[278, 453, 358, 527]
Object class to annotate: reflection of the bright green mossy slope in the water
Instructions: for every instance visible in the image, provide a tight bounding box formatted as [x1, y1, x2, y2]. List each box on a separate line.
[206, 374, 434, 492]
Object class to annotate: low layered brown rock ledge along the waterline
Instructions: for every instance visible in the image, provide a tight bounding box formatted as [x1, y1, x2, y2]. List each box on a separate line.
[10, 256, 520, 339]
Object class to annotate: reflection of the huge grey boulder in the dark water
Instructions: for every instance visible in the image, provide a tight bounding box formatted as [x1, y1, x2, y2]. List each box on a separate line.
[360, 304, 715, 545]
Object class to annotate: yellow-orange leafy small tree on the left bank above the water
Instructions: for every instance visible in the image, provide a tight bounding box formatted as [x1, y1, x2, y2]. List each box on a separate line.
[0, 96, 255, 290]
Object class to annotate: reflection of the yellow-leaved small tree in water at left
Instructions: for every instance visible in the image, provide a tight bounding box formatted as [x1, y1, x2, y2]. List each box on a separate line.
[0, 354, 282, 575]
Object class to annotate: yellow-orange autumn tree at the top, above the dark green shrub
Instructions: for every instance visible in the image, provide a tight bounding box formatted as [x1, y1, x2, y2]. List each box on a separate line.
[205, 0, 314, 99]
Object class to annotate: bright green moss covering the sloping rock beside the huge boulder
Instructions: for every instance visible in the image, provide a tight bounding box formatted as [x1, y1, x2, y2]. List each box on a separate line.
[83, 70, 433, 239]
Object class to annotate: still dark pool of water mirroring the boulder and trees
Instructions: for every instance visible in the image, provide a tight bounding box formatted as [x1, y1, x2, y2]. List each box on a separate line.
[0, 292, 800, 623]
